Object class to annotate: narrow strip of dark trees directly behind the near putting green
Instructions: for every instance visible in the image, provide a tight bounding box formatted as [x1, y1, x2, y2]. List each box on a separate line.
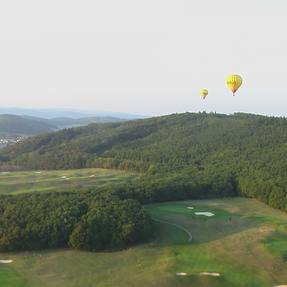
[107, 169, 239, 204]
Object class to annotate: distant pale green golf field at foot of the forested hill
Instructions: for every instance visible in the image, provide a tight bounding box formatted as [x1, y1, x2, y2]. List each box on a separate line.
[0, 168, 135, 194]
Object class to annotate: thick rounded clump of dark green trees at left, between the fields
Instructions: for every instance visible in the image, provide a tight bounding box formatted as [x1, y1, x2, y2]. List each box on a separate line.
[0, 192, 153, 251]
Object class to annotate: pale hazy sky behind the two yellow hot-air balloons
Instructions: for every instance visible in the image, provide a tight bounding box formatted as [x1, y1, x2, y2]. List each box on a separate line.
[0, 0, 287, 115]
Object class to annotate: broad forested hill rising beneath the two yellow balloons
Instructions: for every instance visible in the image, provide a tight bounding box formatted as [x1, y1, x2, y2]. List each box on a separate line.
[0, 113, 287, 209]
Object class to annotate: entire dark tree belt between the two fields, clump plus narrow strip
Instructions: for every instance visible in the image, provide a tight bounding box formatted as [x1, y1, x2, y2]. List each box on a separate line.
[0, 170, 238, 251]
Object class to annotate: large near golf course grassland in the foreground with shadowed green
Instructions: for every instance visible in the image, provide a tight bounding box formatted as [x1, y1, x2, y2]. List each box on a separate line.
[0, 198, 287, 287]
